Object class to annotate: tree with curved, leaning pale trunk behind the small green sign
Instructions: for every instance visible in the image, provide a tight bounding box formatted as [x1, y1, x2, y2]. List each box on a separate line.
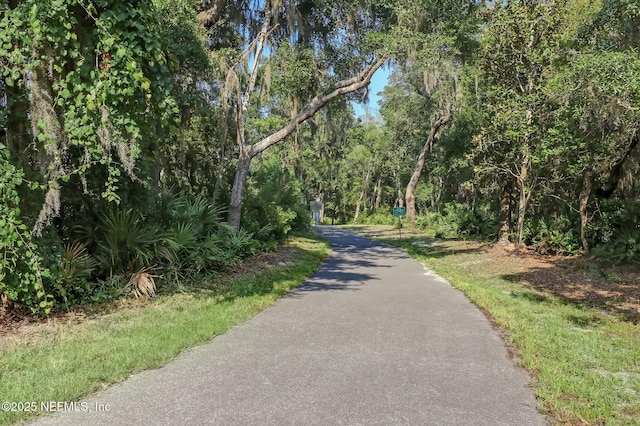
[378, 0, 477, 224]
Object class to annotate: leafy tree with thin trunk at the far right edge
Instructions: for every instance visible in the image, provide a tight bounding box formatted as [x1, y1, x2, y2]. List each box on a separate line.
[549, 52, 640, 252]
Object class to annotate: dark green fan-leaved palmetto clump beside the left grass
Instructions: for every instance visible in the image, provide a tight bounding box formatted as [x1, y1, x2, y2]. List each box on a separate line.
[77, 194, 253, 290]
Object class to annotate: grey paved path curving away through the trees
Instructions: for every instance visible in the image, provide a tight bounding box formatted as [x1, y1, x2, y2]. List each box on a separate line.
[32, 227, 546, 426]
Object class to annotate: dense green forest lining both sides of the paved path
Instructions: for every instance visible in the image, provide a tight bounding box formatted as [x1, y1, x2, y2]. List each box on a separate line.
[0, 0, 640, 315]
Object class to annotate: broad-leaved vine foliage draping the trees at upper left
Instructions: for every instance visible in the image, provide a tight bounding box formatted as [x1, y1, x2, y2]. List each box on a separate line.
[0, 0, 177, 207]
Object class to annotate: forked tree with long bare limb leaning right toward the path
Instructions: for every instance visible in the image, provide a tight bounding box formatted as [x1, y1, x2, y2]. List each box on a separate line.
[211, 1, 386, 229]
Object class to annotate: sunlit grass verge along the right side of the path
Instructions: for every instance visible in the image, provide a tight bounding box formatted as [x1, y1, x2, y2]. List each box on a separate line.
[350, 227, 640, 425]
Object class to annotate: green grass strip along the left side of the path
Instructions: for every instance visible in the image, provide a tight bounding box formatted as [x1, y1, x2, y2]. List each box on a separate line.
[0, 233, 329, 424]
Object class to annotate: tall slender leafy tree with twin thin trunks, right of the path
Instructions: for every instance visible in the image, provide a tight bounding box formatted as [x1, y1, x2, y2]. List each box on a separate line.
[476, 0, 563, 247]
